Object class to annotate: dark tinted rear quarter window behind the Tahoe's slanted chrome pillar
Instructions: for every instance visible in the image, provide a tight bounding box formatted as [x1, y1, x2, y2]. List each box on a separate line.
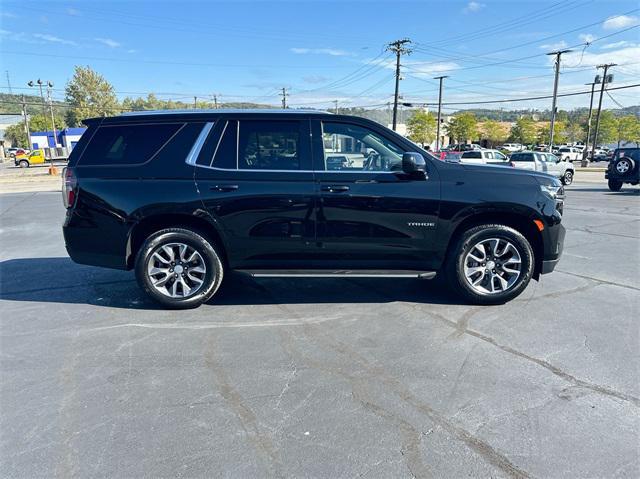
[80, 123, 181, 165]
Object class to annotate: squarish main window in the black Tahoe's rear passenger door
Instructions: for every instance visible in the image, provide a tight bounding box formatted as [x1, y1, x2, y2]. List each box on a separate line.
[238, 121, 300, 170]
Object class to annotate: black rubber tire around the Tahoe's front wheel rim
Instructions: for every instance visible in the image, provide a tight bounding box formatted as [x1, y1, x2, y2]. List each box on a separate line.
[451, 225, 534, 304]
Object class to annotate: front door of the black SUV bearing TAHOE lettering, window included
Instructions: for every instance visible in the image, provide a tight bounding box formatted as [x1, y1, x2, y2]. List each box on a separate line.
[312, 120, 440, 269]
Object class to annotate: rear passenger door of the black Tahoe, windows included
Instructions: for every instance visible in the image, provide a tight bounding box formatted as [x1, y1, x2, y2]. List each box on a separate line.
[195, 118, 316, 269]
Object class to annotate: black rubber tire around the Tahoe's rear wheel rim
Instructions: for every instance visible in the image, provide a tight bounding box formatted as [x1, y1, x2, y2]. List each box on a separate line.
[135, 228, 224, 309]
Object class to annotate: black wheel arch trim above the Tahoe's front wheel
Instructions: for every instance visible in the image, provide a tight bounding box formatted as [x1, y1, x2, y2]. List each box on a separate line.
[446, 210, 544, 280]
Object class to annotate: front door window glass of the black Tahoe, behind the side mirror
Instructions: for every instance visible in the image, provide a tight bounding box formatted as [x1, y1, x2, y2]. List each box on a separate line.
[322, 122, 404, 171]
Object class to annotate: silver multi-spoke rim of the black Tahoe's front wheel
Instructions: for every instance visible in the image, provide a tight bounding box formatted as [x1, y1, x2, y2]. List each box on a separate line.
[464, 238, 522, 294]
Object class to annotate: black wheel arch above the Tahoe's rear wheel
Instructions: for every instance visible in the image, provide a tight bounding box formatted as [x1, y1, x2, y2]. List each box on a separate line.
[126, 213, 227, 269]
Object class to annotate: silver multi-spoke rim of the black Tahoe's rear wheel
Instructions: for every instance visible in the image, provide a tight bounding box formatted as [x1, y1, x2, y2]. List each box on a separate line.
[147, 243, 207, 298]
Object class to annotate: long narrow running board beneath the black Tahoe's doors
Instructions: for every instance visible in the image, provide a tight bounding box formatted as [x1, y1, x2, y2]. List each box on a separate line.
[235, 269, 436, 279]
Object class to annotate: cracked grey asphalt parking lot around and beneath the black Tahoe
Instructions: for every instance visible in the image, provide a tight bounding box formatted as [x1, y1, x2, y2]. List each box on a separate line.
[0, 182, 640, 478]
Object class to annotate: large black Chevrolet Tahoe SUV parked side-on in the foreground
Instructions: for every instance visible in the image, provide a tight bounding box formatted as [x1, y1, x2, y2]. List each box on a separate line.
[63, 110, 564, 308]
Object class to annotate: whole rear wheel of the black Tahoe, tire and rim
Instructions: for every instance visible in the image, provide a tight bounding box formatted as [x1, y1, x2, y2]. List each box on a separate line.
[135, 228, 224, 309]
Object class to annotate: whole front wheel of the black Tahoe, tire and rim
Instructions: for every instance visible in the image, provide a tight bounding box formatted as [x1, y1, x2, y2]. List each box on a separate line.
[445, 224, 534, 304]
